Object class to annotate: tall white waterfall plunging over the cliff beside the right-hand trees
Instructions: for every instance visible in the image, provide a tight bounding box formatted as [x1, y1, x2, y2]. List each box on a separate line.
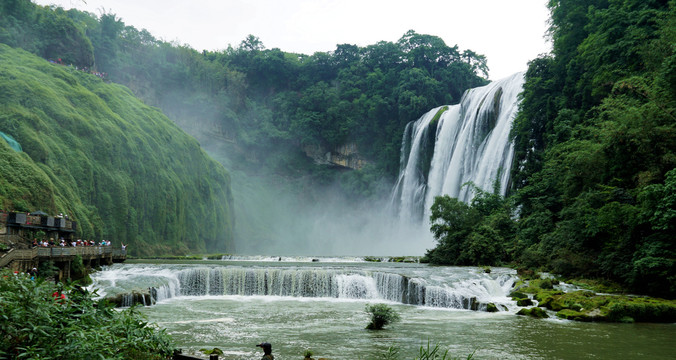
[392, 73, 524, 222]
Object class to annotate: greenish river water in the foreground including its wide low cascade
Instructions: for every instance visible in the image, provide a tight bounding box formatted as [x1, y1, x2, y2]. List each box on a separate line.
[93, 258, 676, 360]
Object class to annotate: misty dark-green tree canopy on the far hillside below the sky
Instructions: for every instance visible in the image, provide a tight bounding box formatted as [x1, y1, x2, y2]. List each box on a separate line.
[0, 0, 488, 180]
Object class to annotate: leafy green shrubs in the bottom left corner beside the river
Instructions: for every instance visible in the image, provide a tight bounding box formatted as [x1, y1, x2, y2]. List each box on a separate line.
[0, 270, 173, 360]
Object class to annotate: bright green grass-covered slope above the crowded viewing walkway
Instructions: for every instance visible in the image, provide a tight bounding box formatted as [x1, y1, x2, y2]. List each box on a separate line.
[0, 44, 234, 255]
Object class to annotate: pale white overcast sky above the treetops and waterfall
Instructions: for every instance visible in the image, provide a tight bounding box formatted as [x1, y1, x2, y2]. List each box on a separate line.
[34, 0, 551, 80]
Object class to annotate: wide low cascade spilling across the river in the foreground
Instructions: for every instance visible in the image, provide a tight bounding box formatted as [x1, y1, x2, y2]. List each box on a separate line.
[94, 265, 515, 310]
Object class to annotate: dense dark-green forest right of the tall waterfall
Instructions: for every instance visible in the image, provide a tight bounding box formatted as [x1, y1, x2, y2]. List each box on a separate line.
[428, 0, 676, 297]
